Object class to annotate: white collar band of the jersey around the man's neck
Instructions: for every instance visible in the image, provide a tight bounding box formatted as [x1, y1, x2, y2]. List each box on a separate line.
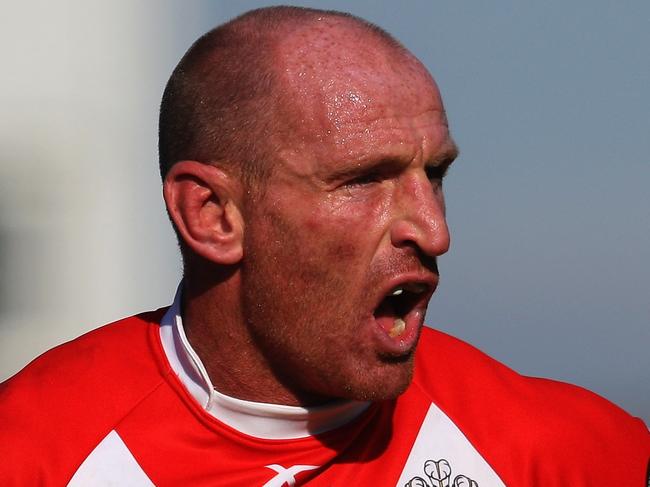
[160, 283, 370, 440]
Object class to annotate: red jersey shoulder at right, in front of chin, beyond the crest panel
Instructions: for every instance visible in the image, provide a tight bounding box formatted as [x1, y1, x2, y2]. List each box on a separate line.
[414, 329, 650, 485]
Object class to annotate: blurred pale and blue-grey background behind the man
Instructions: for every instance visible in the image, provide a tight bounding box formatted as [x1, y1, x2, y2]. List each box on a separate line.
[0, 0, 650, 422]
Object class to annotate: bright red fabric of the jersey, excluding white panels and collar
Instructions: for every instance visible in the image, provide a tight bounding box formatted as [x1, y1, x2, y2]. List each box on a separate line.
[0, 310, 650, 487]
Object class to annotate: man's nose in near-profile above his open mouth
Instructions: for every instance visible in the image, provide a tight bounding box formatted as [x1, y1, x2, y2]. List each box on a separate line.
[390, 175, 450, 257]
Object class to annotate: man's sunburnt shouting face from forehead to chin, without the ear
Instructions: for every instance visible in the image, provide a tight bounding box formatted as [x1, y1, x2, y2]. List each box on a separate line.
[242, 34, 455, 402]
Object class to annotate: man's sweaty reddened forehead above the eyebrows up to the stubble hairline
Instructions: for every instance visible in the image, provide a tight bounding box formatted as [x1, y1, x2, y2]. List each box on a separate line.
[270, 24, 449, 177]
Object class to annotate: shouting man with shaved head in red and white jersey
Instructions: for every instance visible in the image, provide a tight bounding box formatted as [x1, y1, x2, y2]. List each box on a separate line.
[0, 7, 650, 487]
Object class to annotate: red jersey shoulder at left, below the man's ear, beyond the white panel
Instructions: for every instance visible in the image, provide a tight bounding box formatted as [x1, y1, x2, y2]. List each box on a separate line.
[0, 310, 170, 483]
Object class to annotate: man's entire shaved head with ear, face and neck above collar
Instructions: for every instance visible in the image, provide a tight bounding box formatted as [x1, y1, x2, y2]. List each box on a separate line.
[160, 7, 455, 404]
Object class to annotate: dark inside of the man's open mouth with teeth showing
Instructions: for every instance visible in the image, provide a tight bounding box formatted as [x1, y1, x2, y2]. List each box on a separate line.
[374, 282, 431, 338]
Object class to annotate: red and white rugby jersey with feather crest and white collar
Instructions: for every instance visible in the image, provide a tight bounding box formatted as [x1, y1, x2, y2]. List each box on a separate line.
[0, 292, 650, 487]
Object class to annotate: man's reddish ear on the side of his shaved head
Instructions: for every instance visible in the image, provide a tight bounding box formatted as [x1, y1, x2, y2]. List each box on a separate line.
[163, 161, 243, 265]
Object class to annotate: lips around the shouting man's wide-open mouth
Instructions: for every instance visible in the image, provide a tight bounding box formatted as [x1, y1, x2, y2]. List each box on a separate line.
[371, 272, 438, 358]
